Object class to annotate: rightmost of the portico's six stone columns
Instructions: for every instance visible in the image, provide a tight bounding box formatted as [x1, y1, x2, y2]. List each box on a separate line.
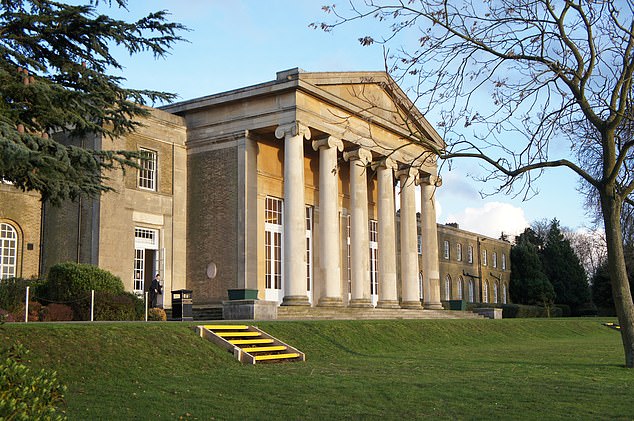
[420, 175, 442, 310]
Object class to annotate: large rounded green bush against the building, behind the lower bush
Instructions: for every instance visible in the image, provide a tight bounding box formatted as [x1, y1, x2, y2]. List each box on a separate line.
[45, 262, 124, 303]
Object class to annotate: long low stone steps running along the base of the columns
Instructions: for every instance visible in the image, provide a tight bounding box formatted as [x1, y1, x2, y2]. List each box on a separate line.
[277, 306, 483, 320]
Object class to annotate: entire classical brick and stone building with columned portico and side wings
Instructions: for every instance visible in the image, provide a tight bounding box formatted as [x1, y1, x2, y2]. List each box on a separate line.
[0, 69, 510, 309]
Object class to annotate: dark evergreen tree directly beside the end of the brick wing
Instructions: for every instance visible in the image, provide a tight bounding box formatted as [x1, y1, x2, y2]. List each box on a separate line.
[509, 228, 555, 307]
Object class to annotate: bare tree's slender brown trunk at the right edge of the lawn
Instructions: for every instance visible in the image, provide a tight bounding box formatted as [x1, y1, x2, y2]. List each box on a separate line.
[600, 189, 634, 368]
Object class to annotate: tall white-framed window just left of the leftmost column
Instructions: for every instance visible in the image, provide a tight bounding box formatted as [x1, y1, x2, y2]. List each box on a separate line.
[264, 197, 283, 289]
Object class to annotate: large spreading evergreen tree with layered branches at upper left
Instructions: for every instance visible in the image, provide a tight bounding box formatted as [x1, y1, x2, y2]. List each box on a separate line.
[0, 0, 185, 203]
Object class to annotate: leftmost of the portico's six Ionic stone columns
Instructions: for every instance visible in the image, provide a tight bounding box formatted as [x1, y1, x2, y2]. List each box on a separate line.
[275, 122, 310, 306]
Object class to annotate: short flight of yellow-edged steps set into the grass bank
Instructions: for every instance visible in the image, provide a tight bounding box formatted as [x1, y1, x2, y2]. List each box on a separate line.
[196, 324, 306, 364]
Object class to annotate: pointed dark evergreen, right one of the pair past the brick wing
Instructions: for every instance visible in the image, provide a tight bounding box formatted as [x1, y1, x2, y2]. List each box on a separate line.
[540, 219, 590, 313]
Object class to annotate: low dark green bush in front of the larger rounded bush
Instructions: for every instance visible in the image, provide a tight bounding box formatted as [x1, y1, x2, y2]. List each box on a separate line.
[72, 292, 145, 320]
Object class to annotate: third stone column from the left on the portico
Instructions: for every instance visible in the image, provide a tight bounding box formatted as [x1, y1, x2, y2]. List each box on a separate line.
[343, 148, 372, 307]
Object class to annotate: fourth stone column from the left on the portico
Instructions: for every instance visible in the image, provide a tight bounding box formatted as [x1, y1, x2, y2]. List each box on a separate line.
[376, 158, 399, 308]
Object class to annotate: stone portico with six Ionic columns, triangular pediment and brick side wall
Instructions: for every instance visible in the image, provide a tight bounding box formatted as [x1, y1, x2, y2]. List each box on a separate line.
[166, 69, 443, 309]
